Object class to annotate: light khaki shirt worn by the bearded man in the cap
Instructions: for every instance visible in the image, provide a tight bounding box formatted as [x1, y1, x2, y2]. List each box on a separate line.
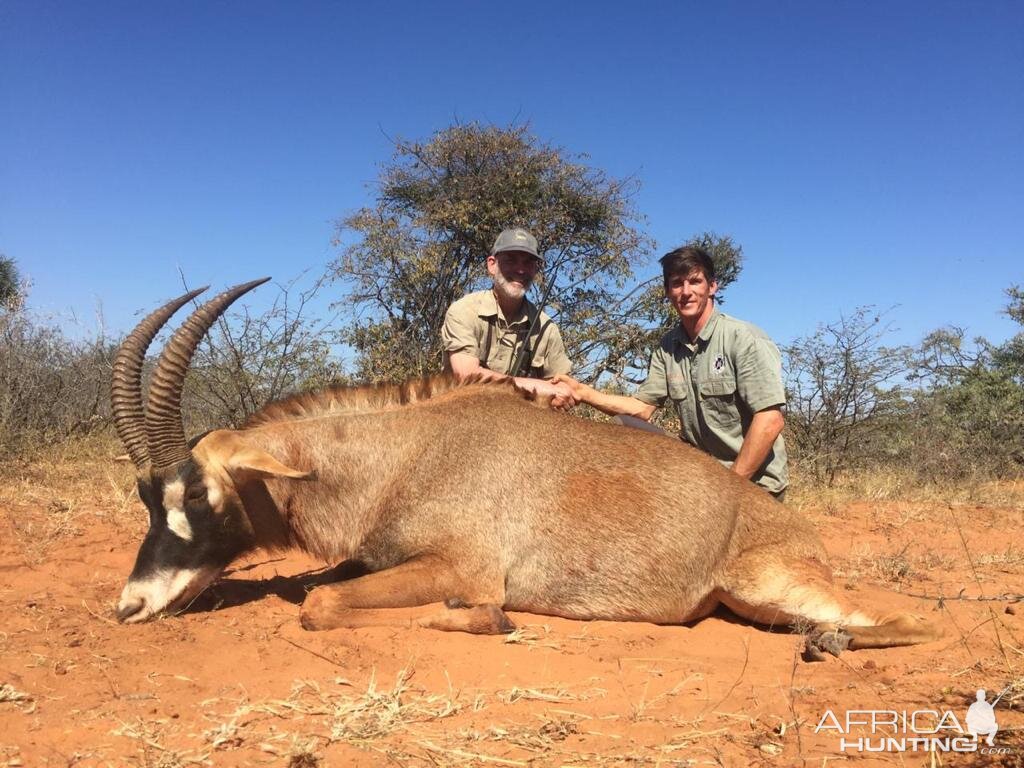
[441, 290, 572, 378]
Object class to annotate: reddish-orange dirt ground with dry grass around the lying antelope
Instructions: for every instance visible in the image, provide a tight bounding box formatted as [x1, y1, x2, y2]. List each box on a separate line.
[0, 459, 1024, 768]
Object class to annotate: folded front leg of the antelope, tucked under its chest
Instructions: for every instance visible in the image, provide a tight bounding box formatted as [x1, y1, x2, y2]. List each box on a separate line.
[299, 557, 515, 634]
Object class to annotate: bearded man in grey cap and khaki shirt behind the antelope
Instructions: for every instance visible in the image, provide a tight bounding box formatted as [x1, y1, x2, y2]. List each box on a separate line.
[441, 227, 573, 407]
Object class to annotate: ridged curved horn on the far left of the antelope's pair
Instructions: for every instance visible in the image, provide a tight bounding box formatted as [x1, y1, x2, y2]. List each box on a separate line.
[111, 286, 209, 468]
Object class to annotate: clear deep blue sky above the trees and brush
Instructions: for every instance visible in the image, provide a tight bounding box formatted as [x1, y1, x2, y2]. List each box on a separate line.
[0, 0, 1024, 350]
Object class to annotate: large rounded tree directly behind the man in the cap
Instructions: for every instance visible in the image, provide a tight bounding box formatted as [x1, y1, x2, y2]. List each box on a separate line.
[330, 124, 651, 381]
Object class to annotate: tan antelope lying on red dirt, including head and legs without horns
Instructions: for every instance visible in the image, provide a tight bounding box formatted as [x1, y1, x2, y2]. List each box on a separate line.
[112, 282, 939, 651]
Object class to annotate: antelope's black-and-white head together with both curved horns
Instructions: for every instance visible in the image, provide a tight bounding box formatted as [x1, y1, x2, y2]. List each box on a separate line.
[111, 279, 268, 623]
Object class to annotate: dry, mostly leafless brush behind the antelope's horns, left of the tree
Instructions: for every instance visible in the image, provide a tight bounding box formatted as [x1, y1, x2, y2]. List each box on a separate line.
[0, 275, 343, 460]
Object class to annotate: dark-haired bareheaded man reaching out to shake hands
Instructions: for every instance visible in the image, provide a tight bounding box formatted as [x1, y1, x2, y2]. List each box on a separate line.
[553, 245, 788, 500]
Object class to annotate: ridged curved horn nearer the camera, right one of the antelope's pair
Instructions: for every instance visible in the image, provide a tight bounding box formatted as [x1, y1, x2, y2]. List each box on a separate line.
[145, 278, 270, 469]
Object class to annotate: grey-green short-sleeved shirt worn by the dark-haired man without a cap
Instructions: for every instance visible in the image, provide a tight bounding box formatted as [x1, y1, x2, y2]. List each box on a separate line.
[636, 309, 790, 494]
